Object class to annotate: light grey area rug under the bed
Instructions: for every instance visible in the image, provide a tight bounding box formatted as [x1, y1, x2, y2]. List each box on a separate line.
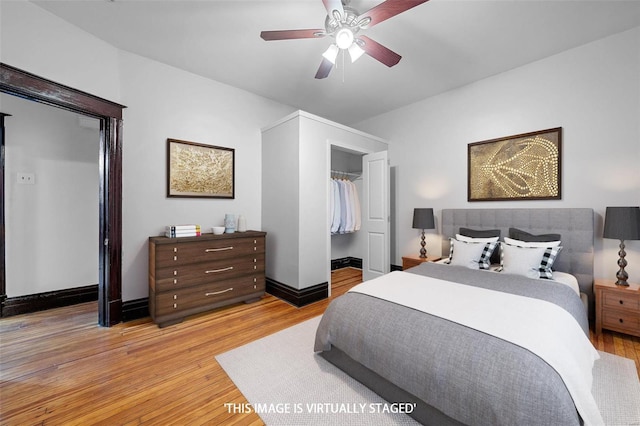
[216, 317, 640, 426]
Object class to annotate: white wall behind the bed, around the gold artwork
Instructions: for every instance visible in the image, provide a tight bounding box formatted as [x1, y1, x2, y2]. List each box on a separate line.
[356, 28, 640, 282]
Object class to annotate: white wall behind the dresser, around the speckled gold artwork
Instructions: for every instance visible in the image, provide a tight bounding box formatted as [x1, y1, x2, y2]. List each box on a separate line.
[119, 52, 293, 301]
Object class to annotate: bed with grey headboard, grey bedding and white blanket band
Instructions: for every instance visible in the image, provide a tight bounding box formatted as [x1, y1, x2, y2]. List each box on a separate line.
[314, 209, 601, 425]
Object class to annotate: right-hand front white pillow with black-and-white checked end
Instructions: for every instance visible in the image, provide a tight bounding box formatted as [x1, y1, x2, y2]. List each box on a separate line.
[500, 243, 562, 279]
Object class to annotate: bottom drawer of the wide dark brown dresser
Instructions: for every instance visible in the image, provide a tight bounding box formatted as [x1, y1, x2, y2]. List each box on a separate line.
[154, 276, 265, 317]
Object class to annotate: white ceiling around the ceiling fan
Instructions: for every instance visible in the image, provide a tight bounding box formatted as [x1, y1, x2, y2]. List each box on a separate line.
[33, 0, 640, 125]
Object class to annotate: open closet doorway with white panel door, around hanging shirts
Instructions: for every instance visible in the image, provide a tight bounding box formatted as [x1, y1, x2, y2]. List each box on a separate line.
[328, 141, 391, 288]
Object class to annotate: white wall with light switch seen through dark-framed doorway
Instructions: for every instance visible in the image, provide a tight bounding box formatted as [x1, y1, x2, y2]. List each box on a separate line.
[0, 93, 100, 297]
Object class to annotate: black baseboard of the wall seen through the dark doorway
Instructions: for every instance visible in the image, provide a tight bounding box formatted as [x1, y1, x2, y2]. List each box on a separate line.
[0, 284, 98, 318]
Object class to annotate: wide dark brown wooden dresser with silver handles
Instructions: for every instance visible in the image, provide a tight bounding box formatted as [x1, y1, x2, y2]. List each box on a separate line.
[149, 231, 266, 327]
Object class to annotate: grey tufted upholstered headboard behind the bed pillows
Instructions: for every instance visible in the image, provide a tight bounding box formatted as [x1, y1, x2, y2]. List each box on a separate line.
[441, 208, 595, 317]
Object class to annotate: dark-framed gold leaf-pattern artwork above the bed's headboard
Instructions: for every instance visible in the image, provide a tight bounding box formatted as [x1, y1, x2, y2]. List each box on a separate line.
[467, 127, 562, 201]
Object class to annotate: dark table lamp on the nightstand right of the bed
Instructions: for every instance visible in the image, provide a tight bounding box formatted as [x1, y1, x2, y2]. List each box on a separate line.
[602, 207, 640, 286]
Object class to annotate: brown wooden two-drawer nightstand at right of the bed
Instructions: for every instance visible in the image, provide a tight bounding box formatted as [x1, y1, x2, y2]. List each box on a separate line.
[594, 279, 640, 337]
